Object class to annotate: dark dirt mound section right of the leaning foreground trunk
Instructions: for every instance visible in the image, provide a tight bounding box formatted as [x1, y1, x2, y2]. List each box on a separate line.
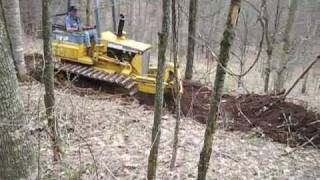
[224, 94, 320, 146]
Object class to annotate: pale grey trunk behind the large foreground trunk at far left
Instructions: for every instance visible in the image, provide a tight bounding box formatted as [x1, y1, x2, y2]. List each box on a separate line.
[0, 0, 27, 81]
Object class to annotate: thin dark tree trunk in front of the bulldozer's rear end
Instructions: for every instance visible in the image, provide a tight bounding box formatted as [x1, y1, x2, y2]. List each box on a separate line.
[42, 0, 60, 161]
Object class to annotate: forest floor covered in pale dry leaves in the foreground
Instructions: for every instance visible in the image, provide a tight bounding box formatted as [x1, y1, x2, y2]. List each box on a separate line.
[21, 82, 320, 180]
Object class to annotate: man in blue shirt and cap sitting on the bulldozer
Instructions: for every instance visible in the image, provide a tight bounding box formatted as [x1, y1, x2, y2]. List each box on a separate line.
[65, 6, 98, 56]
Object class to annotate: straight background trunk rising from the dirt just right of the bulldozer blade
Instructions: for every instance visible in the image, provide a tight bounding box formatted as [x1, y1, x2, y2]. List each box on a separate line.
[185, 0, 198, 80]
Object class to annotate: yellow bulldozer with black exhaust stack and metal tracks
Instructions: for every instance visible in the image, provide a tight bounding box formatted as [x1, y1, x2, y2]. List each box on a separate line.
[52, 0, 180, 95]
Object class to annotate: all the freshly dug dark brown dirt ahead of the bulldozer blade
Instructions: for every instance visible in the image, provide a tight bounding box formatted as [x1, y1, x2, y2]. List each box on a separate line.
[182, 83, 320, 146]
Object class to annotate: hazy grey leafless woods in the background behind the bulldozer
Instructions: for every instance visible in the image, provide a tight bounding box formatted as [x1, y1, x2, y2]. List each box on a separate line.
[20, 0, 320, 108]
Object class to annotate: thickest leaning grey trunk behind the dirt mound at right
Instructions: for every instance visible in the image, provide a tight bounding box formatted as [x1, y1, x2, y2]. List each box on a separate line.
[274, 0, 298, 93]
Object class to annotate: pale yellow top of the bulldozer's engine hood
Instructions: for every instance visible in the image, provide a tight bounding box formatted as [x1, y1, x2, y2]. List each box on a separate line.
[101, 31, 152, 53]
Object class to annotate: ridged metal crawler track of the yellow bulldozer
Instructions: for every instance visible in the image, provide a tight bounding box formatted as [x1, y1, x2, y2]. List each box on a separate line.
[55, 62, 139, 96]
